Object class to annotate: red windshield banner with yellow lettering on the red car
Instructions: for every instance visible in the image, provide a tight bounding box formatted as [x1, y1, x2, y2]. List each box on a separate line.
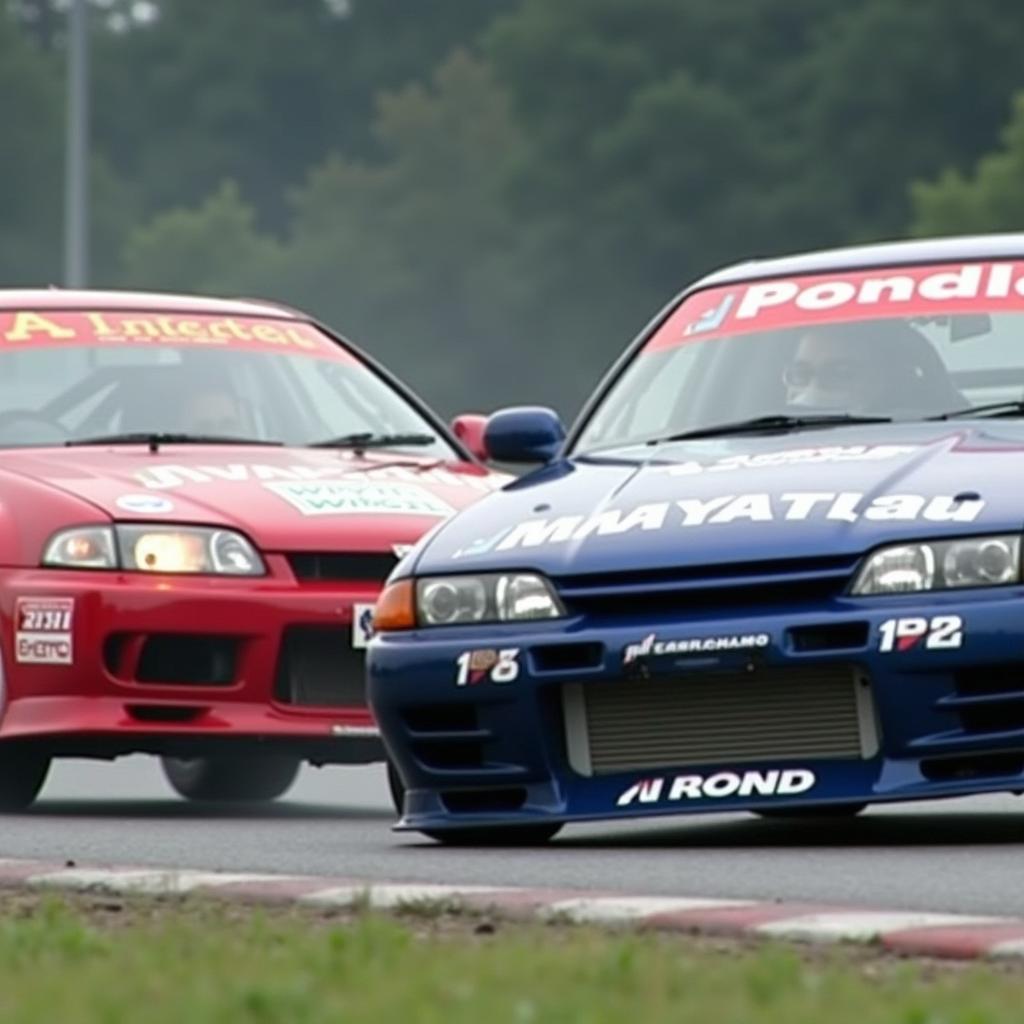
[0, 309, 353, 362]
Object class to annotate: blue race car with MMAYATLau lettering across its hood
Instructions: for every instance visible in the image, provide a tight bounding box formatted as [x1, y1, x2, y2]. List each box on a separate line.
[368, 234, 1024, 843]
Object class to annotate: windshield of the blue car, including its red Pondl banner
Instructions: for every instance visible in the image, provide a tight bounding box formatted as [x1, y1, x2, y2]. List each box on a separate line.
[574, 262, 1024, 452]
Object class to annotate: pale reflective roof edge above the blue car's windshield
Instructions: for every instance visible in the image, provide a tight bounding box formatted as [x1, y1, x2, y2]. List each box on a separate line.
[688, 231, 1024, 291]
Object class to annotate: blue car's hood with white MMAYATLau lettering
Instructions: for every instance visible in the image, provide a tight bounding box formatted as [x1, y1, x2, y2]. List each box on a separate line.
[411, 421, 1024, 577]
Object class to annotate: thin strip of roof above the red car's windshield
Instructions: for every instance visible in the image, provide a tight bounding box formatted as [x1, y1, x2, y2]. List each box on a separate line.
[0, 288, 301, 319]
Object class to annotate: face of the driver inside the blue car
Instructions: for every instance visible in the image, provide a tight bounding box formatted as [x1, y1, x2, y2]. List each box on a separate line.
[783, 334, 884, 411]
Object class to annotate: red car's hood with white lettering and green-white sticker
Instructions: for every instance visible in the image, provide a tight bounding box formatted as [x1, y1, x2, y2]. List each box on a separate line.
[0, 445, 510, 551]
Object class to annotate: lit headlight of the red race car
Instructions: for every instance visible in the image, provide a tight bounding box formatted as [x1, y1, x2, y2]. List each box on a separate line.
[43, 524, 266, 575]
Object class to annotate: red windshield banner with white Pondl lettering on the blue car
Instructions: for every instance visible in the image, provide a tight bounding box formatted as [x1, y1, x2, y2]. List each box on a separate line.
[645, 262, 1024, 352]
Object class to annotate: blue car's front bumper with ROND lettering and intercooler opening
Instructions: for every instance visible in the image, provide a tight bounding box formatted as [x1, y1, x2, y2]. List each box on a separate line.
[368, 588, 1024, 830]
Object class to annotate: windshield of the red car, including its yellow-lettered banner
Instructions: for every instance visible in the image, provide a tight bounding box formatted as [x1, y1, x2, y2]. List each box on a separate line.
[0, 310, 455, 459]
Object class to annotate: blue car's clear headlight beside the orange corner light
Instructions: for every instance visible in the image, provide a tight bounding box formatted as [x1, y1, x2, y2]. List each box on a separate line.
[416, 572, 565, 626]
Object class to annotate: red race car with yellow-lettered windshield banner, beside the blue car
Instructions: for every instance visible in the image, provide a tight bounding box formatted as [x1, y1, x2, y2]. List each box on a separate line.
[0, 290, 509, 810]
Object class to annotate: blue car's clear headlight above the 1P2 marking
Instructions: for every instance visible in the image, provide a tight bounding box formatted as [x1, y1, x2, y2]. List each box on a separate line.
[852, 535, 1021, 596]
